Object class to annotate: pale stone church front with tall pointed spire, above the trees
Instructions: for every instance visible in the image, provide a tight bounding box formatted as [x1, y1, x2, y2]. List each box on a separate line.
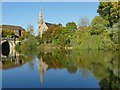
[38, 9, 48, 37]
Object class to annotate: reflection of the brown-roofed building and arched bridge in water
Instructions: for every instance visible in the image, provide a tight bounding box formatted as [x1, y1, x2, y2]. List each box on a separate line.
[0, 48, 32, 69]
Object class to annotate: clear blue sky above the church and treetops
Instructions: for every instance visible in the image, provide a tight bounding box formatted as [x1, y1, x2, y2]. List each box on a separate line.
[2, 2, 99, 32]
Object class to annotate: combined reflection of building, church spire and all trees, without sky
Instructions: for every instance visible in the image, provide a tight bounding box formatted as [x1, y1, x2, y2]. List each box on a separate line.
[1, 47, 120, 90]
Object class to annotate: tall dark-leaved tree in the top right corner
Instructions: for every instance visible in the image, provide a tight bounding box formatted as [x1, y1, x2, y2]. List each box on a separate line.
[97, 2, 120, 27]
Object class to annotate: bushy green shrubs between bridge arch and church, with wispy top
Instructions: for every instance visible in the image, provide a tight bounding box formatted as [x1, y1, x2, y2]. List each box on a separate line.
[16, 25, 38, 53]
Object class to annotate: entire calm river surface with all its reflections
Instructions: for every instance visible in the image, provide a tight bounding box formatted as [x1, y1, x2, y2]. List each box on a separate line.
[2, 50, 120, 89]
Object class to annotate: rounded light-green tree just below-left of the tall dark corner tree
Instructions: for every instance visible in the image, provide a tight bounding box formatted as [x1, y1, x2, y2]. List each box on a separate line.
[91, 16, 109, 35]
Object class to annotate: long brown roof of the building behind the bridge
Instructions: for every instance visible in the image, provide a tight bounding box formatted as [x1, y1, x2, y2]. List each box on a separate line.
[0, 25, 25, 31]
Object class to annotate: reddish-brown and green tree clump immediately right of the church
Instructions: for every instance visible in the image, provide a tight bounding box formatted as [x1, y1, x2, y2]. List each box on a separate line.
[37, 22, 77, 47]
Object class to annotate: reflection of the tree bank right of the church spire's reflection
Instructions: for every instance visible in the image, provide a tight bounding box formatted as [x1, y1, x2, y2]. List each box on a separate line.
[38, 50, 120, 89]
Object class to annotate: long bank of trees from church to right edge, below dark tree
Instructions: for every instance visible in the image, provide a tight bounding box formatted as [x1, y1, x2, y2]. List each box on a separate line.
[37, 16, 120, 50]
